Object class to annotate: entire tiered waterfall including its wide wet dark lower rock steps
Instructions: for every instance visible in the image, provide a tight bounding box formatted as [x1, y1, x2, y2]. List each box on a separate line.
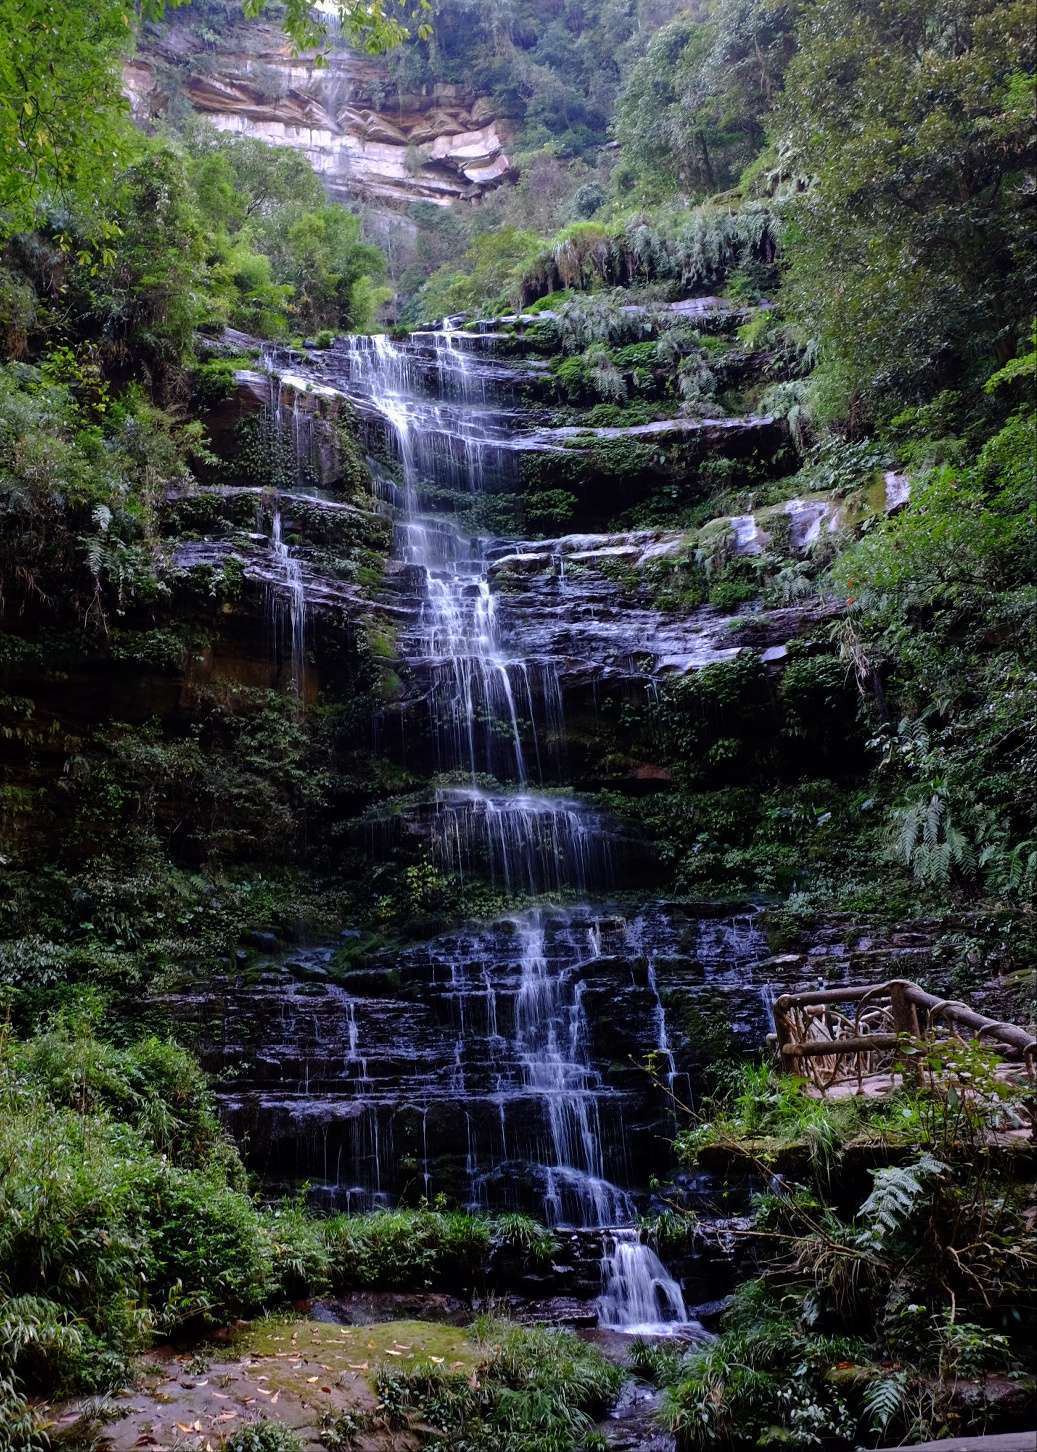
[191, 325, 784, 1327]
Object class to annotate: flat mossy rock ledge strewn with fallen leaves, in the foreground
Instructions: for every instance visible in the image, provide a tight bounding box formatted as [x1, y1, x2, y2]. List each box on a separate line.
[58, 1316, 622, 1452]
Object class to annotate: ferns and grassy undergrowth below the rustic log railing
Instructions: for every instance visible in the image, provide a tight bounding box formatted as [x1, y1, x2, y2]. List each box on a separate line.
[636, 1045, 1037, 1449]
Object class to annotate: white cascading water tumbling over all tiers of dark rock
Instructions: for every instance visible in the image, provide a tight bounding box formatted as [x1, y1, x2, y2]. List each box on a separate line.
[257, 319, 705, 1330]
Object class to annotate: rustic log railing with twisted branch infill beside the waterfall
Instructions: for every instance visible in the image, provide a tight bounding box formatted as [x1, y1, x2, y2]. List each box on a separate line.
[774, 979, 1037, 1115]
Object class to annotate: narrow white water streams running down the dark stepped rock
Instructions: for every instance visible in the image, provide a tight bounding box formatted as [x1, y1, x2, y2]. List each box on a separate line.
[262, 325, 687, 1333]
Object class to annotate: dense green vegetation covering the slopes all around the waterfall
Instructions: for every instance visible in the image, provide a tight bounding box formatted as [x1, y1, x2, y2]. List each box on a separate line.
[0, 0, 1037, 1452]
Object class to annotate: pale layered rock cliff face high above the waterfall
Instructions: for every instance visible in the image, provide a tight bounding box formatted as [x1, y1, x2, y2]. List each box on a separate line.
[125, 12, 511, 206]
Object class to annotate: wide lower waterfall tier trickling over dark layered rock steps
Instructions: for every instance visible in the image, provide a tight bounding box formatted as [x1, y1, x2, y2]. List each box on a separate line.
[175, 905, 774, 1225]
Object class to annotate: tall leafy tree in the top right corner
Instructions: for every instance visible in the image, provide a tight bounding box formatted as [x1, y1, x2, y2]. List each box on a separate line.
[776, 0, 1037, 427]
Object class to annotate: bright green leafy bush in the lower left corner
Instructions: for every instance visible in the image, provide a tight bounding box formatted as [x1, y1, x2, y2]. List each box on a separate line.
[0, 1029, 272, 1391]
